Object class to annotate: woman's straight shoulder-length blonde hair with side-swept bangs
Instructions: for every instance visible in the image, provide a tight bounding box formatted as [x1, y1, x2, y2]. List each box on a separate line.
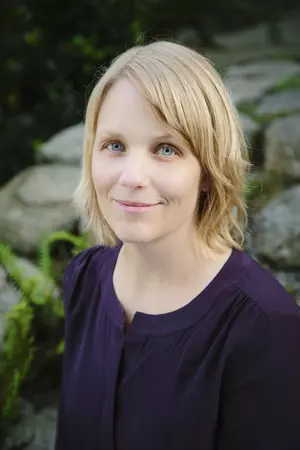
[74, 41, 250, 251]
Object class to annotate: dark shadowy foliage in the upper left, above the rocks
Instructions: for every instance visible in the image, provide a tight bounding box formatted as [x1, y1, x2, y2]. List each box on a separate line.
[0, 0, 139, 183]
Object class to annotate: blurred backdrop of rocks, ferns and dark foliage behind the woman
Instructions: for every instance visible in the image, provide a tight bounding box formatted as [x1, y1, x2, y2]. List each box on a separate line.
[0, 0, 300, 450]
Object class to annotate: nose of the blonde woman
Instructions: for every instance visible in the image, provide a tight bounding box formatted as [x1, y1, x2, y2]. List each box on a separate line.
[119, 152, 149, 189]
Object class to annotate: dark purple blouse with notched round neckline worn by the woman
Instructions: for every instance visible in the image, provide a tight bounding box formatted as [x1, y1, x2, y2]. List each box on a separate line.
[56, 246, 300, 450]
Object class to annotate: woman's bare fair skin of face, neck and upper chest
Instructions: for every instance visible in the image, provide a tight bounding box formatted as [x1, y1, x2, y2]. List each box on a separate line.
[92, 79, 229, 321]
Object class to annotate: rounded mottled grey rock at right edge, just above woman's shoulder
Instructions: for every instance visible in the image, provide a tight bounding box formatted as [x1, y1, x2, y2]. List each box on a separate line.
[252, 186, 300, 270]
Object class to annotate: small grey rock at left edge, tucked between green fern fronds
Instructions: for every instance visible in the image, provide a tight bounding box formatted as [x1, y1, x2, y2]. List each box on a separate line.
[0, 267, 20, 348]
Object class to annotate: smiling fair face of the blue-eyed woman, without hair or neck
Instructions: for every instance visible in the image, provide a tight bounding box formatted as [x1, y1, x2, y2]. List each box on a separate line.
[92, 79, 201, 243]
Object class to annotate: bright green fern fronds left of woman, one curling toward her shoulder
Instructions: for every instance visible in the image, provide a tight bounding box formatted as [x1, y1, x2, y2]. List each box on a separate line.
[0, 231, 89, 427]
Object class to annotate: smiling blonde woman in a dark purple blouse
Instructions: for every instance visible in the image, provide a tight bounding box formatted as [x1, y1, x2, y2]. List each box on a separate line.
[56, 42, 300, 450]
